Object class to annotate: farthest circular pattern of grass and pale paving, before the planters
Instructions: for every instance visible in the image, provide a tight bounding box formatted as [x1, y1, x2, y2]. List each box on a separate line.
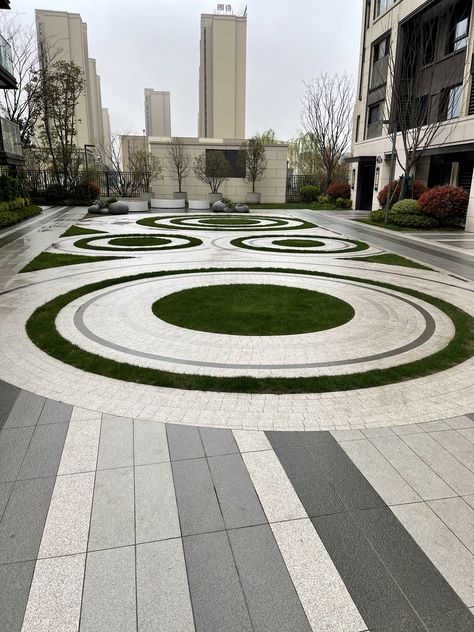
[137, 214, 316, 231]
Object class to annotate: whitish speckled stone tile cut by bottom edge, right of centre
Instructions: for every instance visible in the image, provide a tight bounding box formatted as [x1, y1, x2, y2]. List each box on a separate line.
[271, 518, 367, 632]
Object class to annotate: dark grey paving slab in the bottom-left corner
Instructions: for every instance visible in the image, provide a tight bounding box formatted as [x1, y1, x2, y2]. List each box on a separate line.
[0, 562, 35, 632]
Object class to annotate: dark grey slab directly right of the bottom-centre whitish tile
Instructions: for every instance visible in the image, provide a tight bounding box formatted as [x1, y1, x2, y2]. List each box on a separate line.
[312, 513, 426, 632]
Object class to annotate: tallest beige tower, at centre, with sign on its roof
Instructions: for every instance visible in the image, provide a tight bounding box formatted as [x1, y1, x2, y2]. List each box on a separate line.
[198, 4, 247, 139]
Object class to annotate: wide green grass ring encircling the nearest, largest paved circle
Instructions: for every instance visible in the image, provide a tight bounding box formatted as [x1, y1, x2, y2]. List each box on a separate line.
[26, 267, 474, 394]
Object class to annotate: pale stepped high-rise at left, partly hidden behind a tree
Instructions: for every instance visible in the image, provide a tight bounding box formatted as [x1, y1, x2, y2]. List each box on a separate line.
[35, 9, 110, 152]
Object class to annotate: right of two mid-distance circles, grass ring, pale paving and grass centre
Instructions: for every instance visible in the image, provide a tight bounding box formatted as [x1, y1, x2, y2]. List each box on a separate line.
[230, 234, 369, 255]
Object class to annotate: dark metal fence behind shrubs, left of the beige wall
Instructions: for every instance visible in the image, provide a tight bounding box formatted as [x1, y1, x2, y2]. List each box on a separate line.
[18, 169, 151, 197]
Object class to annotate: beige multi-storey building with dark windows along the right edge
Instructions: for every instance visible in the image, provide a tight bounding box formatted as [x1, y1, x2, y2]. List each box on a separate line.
[352, 0, 474, 229]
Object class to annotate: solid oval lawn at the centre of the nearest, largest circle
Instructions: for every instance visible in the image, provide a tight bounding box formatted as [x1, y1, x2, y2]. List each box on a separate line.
[153, 283, 354, 336]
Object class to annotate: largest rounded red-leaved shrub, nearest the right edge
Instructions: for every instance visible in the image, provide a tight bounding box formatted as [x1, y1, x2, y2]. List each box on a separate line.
[419, 185, 469, 225]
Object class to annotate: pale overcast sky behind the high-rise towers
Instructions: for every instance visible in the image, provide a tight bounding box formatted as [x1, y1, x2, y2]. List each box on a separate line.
[11, 0, 362, 140]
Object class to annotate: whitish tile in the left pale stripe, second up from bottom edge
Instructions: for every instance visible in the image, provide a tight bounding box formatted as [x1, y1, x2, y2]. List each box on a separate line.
[38, 472, 95, 558]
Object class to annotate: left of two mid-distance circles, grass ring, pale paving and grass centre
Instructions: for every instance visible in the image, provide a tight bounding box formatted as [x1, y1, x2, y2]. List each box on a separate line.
[74, 233, 202, 252]
